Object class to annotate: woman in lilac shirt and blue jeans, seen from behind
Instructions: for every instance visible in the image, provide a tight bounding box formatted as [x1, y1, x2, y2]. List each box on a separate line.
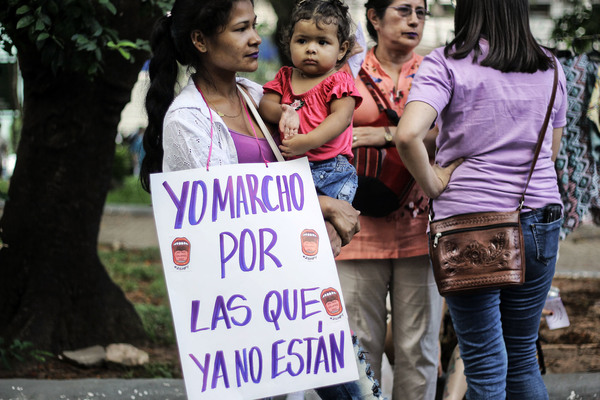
[395, 0, 567, 399]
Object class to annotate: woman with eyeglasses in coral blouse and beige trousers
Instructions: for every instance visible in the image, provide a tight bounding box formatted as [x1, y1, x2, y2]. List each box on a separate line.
[336, 0, 442, 400]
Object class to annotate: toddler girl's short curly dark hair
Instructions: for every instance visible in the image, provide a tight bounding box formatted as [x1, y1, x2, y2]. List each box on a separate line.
[281, 0, 355, 65]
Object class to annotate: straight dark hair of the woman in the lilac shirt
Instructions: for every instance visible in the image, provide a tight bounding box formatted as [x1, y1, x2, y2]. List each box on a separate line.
[444, 0, 552, 73]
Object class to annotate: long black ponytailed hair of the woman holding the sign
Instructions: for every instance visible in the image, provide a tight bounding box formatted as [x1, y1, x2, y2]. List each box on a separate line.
[140, 0, 254, 192]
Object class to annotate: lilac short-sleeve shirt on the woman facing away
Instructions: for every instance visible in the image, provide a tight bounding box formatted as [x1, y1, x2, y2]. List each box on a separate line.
[407, 41, 567, 220]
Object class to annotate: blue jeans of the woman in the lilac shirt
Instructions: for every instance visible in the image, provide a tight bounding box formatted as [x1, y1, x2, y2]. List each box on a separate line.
[446, 209, 561, 400]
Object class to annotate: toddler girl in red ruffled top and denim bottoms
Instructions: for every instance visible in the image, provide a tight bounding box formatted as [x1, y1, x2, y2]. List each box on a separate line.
[259, 0, 362, 203]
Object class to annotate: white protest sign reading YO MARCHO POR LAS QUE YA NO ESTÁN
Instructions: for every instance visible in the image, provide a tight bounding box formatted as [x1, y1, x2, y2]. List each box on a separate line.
[151, 158, 358, 400]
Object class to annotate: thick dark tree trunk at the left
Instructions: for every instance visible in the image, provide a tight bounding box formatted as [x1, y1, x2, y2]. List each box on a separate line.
[0, 0, 159, 353]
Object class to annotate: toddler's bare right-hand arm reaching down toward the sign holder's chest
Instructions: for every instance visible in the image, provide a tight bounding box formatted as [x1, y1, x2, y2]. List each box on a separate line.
[279, 96, 355, 157]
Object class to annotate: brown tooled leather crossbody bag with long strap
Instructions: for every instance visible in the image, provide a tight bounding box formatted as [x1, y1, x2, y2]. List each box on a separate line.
[429, 63, 558, 296]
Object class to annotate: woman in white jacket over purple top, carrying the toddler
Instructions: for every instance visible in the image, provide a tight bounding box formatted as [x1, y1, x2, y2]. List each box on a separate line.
[140, 0, 379, 399]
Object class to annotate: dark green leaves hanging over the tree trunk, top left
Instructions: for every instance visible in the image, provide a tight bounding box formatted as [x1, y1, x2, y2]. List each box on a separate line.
[0, 0, 173, 77]
